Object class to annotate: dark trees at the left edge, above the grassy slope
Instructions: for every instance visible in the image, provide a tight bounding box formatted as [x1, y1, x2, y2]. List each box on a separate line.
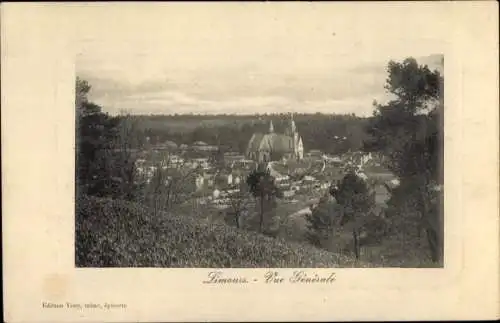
[75, 77, 143, 200]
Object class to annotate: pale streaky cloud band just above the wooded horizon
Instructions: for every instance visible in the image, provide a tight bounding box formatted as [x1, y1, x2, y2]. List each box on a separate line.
[79, 55, 442, 115]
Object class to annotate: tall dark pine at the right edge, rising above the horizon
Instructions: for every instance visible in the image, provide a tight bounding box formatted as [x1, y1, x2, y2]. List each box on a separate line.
[365, 58, 444, 262]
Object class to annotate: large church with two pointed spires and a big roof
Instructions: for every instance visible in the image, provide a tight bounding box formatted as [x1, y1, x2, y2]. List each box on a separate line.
[246, 115, 304, 162]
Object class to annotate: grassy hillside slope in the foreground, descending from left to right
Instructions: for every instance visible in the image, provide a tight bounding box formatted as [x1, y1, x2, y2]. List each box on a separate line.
[75, 197, 366, 268]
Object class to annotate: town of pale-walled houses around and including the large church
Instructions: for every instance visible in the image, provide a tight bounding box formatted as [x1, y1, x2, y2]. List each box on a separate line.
[137, 115, 398, 213]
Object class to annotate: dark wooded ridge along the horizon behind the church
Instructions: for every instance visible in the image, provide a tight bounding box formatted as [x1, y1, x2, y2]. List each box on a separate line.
[117, 113, 371, 154]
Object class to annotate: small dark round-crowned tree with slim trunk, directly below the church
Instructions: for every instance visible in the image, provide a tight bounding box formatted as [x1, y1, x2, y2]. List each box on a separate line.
[247, 168, 282, 232]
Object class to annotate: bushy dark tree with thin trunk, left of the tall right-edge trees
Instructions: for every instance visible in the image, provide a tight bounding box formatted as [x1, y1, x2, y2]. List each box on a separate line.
[331, 172, 375, 259]
